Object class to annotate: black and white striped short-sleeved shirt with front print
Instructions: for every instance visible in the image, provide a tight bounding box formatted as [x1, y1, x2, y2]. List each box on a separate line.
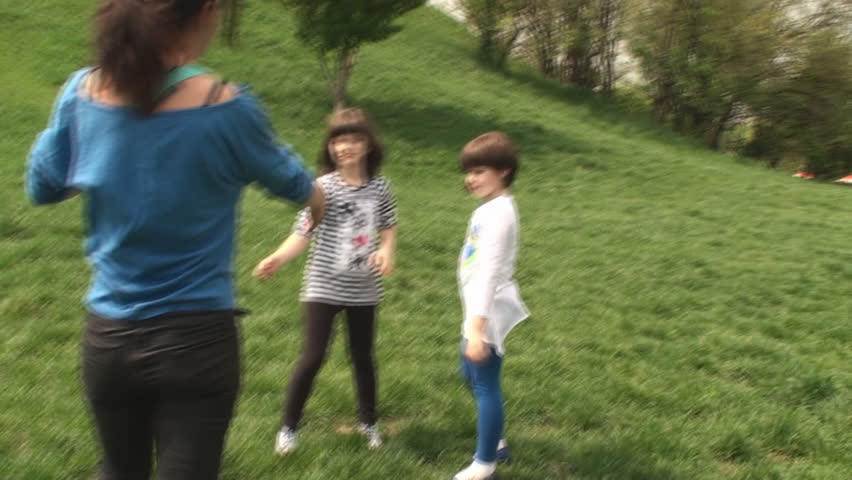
[294, 172, 396, 306]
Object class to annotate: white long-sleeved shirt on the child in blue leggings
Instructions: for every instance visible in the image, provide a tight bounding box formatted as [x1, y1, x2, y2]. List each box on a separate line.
[458, 194, 529, 356]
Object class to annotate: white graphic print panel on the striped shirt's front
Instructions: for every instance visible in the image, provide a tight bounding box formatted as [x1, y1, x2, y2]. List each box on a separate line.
[337, 200, 376, 272]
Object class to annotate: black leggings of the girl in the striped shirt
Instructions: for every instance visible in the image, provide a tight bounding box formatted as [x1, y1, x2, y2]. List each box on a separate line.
[283, 302, 376, 430]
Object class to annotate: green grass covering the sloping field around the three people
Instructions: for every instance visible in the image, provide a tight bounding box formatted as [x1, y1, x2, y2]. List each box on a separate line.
[0, 0, 852, 480]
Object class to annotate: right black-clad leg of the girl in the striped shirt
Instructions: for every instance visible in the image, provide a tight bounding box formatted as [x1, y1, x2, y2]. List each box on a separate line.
[346, 305, 376, 425]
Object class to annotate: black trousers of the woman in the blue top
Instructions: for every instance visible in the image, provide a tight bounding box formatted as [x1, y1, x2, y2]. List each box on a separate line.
[82, 310, 240, 480]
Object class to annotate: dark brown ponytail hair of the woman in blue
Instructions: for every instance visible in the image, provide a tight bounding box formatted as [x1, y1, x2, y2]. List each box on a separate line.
[95, 0, 220, 113]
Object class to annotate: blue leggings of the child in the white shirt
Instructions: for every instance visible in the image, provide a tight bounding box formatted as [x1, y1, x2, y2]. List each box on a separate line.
[461, 340, 503, 463]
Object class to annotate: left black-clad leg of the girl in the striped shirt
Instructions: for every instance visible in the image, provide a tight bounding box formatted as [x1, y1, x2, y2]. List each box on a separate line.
[283, 302, 342, 431]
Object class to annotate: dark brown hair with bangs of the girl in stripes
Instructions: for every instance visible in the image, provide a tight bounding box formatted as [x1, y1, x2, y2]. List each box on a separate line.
[320, 108, 385, 178]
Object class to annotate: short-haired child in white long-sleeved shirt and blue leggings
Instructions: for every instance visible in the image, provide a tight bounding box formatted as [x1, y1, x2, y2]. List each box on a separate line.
[454, 132, 529, 480]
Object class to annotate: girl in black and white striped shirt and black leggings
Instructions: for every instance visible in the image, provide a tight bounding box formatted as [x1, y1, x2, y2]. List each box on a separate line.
[254, 108, 396, 455]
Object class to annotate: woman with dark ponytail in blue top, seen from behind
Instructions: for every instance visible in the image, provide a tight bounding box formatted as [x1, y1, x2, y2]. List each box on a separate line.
[26, 0, 324, 480]
